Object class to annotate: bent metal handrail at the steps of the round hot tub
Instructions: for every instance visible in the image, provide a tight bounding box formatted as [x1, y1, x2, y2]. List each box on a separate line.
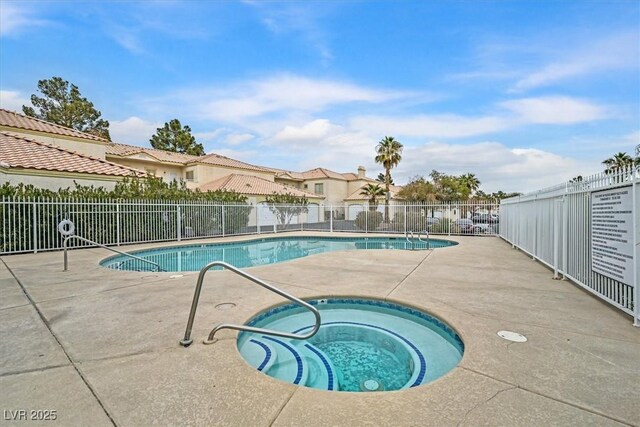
[180, 261, 320, 347]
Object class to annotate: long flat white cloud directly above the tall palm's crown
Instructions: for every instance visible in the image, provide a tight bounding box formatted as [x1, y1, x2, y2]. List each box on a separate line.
[349, 114, 511, 138]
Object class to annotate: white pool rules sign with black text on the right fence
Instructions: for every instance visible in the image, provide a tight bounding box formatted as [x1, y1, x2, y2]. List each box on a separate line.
[591, 186, 634, 286]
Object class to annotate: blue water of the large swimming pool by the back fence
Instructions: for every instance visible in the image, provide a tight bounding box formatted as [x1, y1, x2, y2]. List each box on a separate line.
[100, 236, 457, 271]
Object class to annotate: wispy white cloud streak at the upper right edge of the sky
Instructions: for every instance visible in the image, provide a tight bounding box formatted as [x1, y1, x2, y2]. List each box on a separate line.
[511, 31, 640, 92]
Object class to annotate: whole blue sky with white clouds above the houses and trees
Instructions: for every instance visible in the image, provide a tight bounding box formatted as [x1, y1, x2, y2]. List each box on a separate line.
[0, 0, 640, 191]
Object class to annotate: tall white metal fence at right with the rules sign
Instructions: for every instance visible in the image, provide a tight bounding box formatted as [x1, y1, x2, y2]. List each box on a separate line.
[500, 169, 640, 326]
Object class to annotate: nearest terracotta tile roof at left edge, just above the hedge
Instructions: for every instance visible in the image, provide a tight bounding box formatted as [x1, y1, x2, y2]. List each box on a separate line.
[0, 132, 145, 176]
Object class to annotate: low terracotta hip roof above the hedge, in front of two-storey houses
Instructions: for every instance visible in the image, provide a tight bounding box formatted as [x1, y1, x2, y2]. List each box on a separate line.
[198, 173, 324, 199]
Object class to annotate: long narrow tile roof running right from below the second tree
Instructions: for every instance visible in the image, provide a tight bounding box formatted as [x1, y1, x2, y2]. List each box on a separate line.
[106, 143, 272, 172]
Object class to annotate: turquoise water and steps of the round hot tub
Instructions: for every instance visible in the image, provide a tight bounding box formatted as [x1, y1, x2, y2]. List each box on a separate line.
[238, 298, 464, 392]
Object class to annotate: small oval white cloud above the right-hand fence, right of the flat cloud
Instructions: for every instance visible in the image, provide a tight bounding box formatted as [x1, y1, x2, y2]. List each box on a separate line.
[500, 96, 608, 124]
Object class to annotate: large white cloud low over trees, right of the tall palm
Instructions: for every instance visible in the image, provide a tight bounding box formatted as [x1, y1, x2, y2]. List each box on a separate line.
[393, 142, 582, 192]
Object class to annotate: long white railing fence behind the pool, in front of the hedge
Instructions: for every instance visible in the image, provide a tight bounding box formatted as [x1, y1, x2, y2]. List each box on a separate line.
[0, 198, 500, 254]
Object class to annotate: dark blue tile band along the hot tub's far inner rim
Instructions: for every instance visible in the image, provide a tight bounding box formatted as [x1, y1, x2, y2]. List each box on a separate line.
[247, 298, 464, 355]
